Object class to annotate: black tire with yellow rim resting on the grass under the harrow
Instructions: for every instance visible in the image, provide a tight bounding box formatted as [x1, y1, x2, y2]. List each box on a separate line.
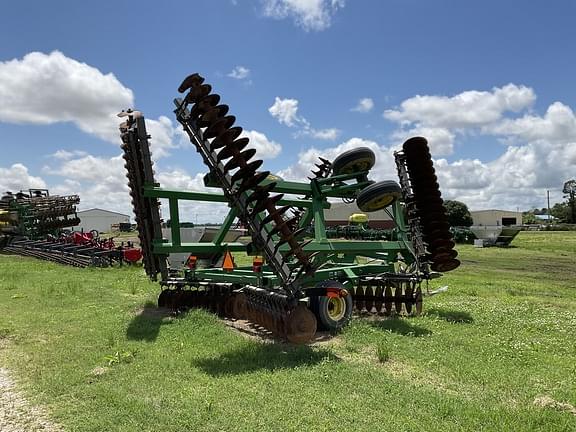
[310, 281, 354, 332]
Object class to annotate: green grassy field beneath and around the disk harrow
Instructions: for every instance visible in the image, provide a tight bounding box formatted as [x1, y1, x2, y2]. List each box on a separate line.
[0, 232, 576, 431]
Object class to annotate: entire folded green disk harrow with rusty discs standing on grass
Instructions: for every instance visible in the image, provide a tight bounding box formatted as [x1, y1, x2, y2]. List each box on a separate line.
[120, 74, 459, 343]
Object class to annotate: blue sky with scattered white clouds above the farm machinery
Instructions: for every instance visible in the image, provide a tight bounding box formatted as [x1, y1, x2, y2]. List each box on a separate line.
[0, 0, 576, 220]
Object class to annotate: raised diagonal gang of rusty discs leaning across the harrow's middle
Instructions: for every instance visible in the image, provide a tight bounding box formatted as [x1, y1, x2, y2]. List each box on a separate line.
[174, 74, 313, 296]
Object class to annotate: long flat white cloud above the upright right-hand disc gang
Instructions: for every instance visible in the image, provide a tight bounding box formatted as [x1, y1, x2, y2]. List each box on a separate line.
[384, 84, 536, 128]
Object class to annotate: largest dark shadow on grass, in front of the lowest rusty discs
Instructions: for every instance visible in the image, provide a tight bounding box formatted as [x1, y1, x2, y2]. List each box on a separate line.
[192, 343, 340, 377]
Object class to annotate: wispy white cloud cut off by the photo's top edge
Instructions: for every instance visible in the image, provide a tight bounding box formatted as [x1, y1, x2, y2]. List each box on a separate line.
[262, 0, 345, 31]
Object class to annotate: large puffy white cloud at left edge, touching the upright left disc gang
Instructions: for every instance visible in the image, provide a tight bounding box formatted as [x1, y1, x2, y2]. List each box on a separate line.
[0, 51, 134, 143]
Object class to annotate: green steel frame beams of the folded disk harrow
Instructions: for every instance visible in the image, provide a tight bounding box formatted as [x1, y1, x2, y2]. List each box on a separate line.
[144, 171, 414, 287]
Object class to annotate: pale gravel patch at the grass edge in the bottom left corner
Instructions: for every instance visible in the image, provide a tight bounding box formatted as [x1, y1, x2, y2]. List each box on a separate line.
[0, 368, 62, 432]
